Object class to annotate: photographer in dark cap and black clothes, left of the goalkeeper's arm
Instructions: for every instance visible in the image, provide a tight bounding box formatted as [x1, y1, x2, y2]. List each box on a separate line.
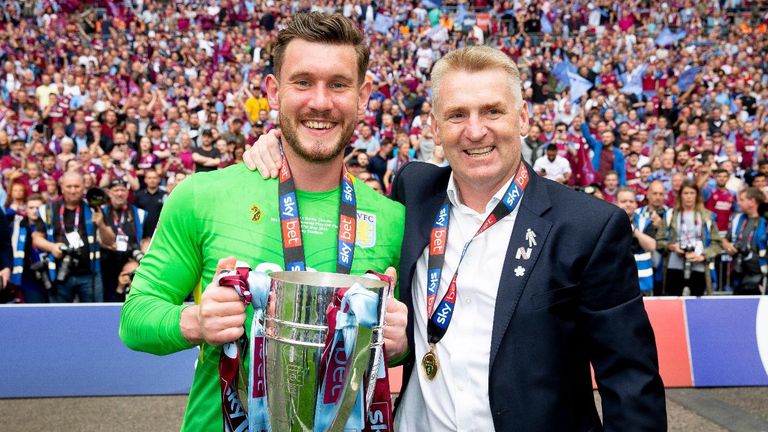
[102, 179, 147, 302]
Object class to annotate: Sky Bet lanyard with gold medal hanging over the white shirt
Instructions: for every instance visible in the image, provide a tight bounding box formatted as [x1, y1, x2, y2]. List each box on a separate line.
[421, 162, 529, 380]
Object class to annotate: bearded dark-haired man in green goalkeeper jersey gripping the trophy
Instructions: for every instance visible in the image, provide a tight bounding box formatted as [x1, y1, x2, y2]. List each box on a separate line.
[120, 14, 407, 431]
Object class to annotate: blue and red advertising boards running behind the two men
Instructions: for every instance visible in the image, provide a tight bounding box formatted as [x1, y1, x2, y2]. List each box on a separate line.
[0, 296, 768, 398]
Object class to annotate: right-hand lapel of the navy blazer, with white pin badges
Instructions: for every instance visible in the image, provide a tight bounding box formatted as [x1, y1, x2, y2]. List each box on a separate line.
[489, 164, 552, 367]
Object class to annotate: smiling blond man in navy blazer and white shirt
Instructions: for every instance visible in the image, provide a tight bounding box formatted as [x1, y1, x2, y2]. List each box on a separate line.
[392, 47, 666, 431]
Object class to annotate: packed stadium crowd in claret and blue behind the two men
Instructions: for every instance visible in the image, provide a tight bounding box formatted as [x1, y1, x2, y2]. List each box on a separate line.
[0, 0, 768, 302]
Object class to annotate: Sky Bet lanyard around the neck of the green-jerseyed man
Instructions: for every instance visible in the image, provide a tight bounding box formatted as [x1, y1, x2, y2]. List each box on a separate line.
[277, 146, 357, 274]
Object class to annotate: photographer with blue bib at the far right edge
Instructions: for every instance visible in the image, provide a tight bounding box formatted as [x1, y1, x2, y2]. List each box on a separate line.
[723, 187, 768, 295]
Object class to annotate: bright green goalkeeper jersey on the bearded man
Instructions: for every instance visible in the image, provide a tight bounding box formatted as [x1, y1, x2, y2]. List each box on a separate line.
[120, 164, 405, 432]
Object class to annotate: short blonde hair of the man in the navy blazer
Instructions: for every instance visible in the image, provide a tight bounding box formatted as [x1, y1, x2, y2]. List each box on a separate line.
[432, 45, 523, 112]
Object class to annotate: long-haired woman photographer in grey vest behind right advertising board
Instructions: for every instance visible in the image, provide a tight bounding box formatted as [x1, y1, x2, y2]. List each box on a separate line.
[656, 180, 721, 296]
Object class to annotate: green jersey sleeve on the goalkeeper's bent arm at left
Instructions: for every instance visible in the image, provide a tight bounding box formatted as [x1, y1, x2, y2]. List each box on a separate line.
[120, 178, 203, 355]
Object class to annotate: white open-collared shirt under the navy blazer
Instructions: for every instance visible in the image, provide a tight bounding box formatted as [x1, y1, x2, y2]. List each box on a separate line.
[395, 174, 519, 432]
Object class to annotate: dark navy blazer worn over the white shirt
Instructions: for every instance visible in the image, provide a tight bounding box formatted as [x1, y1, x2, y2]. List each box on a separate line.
[392, 163, 667, 432]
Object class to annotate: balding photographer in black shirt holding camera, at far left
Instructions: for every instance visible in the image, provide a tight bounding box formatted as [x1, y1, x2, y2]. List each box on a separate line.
[32, 171, 114, 303]
